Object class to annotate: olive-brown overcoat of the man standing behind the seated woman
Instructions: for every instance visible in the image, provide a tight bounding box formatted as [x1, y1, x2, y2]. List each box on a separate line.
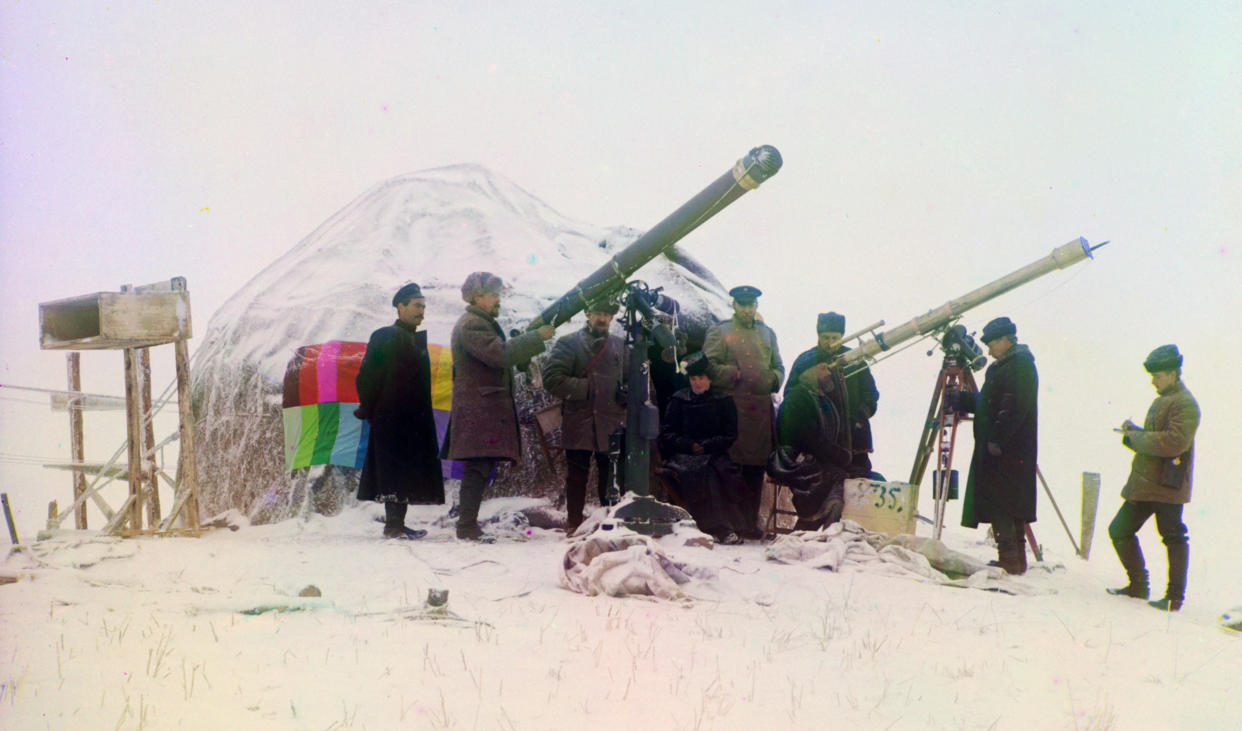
[703, 318, 785, 465]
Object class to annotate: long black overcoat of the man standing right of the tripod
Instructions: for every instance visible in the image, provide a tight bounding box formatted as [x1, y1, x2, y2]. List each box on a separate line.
[961, 343, 1040, 527]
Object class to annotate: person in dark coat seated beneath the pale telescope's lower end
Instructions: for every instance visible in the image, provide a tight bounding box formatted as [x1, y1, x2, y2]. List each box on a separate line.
[769, 362, 852, 530]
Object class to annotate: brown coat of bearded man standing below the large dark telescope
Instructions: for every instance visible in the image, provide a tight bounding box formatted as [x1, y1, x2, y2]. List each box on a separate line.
[543, 328, 626, 452]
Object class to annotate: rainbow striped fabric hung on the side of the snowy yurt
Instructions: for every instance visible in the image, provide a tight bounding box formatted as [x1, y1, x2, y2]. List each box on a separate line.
[282, 340, 462, 478]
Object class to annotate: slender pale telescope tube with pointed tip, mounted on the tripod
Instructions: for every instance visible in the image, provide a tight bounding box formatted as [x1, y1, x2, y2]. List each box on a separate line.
[836, 237, 1108, 367]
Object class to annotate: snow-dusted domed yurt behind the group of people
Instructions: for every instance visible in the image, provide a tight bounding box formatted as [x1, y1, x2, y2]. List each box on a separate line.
[194, 165, 728, 521]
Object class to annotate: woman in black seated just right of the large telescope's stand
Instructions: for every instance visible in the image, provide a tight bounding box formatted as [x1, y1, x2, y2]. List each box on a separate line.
[660, 352, 744, 545]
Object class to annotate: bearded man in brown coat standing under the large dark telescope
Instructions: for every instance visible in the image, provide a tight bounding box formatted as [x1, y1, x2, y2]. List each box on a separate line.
[543, 299, 626, 535]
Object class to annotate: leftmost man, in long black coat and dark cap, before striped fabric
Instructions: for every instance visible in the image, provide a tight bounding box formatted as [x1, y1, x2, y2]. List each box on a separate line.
[355, 282, 445, 539]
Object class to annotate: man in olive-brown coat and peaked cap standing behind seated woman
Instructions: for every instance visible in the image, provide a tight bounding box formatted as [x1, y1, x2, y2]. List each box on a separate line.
[703, 284, 785, 539]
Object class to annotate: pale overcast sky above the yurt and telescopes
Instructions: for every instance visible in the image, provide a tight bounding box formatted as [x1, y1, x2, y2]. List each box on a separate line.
[0, 0, 1242, 588]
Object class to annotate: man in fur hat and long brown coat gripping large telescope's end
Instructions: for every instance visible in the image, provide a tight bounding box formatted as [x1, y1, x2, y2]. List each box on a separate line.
[443, 272, 554, 541]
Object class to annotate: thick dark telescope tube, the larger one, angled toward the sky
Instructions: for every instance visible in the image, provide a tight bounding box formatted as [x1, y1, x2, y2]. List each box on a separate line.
[527, 145, 781, 330]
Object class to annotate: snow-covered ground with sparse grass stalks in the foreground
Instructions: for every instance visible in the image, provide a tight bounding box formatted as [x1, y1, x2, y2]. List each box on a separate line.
[0, 501, 1242, 730]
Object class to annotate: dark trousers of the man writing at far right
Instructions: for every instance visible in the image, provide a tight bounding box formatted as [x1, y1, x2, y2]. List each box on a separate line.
[1108, 500, 1190, 601]
